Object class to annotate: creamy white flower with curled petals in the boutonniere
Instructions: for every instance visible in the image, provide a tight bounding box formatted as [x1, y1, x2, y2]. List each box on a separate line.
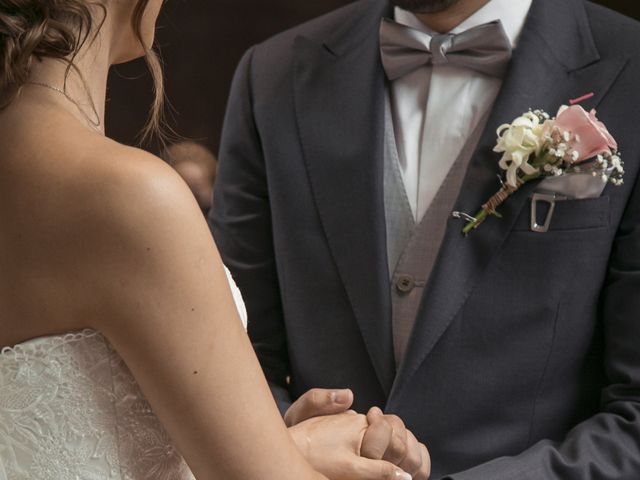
[493, 112, 549, 188]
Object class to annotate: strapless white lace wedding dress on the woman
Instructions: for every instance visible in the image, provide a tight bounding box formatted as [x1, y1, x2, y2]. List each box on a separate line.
[0, 272, 247, 480]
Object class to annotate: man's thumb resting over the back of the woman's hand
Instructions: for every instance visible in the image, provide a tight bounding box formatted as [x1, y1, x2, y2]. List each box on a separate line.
[284, 388, 353, 427]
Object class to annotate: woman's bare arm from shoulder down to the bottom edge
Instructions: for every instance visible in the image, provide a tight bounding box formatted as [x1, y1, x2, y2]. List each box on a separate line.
[77, 152, 324, 480]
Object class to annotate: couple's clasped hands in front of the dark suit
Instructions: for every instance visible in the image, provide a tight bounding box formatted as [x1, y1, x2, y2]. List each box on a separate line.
[285, 389, 431, 480]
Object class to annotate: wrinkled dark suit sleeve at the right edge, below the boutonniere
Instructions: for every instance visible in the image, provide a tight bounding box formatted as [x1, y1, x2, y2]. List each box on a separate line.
[445, 172, 640, 480]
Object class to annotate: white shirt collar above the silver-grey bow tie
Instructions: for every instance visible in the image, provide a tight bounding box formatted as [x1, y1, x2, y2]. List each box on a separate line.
[394, 0, 533, 48]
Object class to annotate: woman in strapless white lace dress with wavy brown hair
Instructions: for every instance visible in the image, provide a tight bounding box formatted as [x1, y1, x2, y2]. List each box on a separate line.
[0, 0, 430, 480]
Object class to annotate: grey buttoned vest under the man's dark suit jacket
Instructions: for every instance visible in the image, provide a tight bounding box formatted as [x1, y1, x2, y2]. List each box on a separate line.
[384, 96, 489, 367]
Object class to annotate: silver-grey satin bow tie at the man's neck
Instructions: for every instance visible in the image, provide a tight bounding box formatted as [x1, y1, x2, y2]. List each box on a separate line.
[380, 18, 512, 81]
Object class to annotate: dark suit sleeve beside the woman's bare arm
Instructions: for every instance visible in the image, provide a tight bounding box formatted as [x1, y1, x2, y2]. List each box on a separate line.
[209, 49, 291, 412]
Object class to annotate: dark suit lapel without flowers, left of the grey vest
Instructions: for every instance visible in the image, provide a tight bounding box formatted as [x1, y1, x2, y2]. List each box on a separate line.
[294, 0, 395, 394]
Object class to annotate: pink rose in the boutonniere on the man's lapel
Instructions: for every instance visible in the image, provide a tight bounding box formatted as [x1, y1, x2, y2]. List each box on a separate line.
[555, 105, 618, 163]
